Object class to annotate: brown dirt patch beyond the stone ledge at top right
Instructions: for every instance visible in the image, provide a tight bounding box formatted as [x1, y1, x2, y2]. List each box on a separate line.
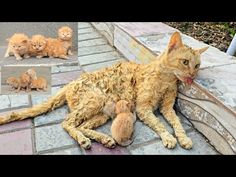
[165, 22, 236, 52]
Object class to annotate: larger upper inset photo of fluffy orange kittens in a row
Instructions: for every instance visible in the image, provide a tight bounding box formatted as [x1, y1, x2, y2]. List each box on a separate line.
[0, 22, 78, 66]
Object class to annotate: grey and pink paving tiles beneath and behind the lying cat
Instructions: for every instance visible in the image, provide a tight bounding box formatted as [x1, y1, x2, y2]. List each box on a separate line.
[0, 23, 218, 155]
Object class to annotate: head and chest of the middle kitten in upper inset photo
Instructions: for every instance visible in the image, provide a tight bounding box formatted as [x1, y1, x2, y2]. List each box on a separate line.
[29, 34, 47, 58]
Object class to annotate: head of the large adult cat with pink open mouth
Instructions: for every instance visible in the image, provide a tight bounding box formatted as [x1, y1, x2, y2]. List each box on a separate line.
[164, 32, 208, 84]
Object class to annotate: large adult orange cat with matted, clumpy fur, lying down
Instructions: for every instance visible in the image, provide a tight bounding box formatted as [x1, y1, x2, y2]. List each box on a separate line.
[0, 32, 208, 149]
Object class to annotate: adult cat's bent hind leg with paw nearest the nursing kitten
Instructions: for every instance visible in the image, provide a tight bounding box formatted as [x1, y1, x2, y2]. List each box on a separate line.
[78, 115, 116, 148]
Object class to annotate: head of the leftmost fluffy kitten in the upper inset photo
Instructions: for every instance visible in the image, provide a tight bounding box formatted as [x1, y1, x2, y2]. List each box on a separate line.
[7, 33, 29, 52]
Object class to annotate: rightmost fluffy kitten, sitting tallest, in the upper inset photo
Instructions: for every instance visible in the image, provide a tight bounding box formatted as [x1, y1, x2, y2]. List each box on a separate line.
[58, 26, 73, 55]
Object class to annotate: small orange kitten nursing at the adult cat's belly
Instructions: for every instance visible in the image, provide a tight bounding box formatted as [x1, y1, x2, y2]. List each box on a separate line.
[111, 100, 136, 146]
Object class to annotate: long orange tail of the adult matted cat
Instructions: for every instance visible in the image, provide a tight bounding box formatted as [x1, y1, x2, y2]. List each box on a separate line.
[0, 86, 67, 125]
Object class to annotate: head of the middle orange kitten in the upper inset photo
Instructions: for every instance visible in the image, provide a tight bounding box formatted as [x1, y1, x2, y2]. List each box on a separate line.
[30, 35, 47, 52]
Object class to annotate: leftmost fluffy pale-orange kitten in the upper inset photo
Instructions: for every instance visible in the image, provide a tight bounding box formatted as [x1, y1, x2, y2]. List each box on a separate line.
[5, 33, 29, 60]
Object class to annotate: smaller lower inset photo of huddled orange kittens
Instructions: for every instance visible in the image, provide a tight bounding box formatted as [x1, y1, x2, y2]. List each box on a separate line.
[1, 66, 51, 95]
